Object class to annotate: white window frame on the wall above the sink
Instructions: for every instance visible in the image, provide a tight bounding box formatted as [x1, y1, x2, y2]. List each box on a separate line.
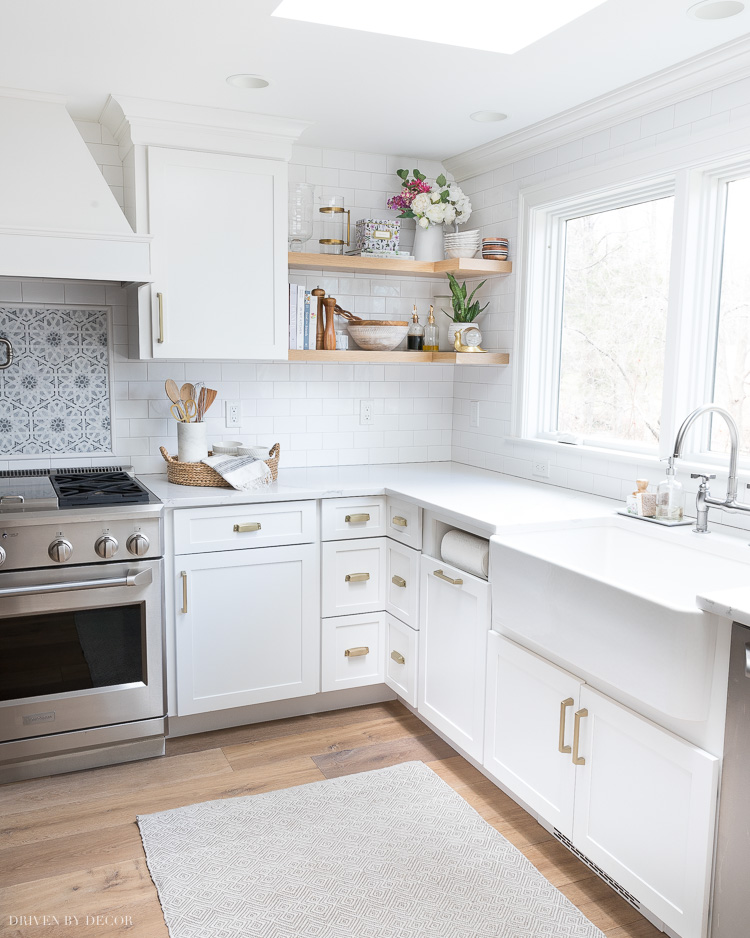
[511, 147, 750, 468]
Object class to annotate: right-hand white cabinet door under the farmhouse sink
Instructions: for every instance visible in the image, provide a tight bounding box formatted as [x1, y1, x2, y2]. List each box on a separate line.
[573, 686, 719, 938]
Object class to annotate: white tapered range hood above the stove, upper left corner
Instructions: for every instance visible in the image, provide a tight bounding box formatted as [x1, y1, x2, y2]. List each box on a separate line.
[0, 89, 151, 282]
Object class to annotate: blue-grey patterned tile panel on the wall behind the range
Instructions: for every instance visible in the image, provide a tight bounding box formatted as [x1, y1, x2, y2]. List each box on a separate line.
[0, 305, 112, 456]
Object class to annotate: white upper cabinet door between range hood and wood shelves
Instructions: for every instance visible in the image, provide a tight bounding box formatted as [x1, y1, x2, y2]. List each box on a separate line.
[147, 147, 288, 359]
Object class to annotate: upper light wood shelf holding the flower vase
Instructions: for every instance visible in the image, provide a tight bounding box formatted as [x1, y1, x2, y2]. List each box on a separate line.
[289, 251, 513, 277]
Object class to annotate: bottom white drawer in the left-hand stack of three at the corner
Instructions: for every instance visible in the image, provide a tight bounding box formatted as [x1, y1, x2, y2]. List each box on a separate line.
[321, 612, 385, 691]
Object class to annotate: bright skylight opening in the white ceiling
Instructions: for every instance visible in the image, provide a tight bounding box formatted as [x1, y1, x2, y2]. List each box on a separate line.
[272, 0, 604, 55]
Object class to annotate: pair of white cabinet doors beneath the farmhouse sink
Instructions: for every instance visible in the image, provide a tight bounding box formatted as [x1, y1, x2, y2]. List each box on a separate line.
[483, 631, 718, 938]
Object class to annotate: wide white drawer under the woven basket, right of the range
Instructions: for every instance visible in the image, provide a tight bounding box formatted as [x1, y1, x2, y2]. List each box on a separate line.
[174, 501, 315, 554]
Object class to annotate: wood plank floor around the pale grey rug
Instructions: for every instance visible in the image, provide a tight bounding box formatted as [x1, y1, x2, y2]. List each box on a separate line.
[0, 701, 661, 938]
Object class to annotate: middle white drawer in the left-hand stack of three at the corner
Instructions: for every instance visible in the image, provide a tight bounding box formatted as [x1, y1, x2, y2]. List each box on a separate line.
[321, 537, 386, 616]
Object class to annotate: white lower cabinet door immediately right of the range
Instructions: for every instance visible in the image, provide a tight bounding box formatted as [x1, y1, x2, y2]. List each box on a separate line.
[174, 544, 320, 716]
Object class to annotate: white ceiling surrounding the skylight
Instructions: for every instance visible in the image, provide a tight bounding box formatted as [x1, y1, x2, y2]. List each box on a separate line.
[0, 0, 750, 159]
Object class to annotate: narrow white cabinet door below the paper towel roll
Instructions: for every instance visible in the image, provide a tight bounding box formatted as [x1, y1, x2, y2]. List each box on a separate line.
[417, 557, 490, 760]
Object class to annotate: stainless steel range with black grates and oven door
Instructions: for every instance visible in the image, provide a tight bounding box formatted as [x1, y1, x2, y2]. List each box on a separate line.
[0, 467, 166, 782]
